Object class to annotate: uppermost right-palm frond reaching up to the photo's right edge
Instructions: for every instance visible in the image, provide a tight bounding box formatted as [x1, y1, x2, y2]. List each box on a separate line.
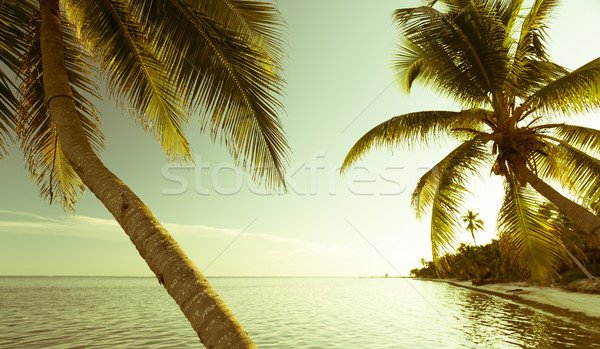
[522, 58, 600, 115]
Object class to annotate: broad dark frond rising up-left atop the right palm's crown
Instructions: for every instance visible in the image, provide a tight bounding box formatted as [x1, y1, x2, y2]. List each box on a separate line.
[393, 1, 509, 106]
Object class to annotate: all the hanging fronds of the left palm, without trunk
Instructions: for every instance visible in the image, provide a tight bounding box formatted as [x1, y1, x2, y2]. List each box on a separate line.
[0, 0, 288, 210]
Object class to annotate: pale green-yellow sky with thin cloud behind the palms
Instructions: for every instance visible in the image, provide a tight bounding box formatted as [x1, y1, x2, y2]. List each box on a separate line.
[0, 0, 600, 277]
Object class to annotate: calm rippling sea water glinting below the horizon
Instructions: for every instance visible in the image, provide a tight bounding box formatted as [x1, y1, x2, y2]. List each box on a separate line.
[0, 277, 600, 349]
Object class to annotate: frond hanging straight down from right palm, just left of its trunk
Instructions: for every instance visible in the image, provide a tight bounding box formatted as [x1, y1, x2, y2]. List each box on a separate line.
[498, 175, 561, 282]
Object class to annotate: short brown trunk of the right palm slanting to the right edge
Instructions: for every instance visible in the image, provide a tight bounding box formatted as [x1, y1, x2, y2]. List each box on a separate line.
[513, 162, 600, 239]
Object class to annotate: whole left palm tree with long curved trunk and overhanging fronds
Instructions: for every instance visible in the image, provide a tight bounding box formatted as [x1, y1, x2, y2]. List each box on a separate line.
[0, 0, 287, 348]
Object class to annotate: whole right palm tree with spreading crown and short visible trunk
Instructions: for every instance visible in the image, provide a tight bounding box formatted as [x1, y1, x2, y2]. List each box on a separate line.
[342, 0, 600, 280]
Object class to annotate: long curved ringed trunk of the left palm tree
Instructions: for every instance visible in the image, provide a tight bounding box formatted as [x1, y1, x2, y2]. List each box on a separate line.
[40, 0, 256, 348]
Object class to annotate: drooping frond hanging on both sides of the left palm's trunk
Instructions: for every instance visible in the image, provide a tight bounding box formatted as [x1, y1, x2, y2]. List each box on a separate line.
[17, 12, 104, 211]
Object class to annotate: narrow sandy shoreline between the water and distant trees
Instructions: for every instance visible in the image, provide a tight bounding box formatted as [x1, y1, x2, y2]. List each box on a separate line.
[420, 279, 600, 320]
